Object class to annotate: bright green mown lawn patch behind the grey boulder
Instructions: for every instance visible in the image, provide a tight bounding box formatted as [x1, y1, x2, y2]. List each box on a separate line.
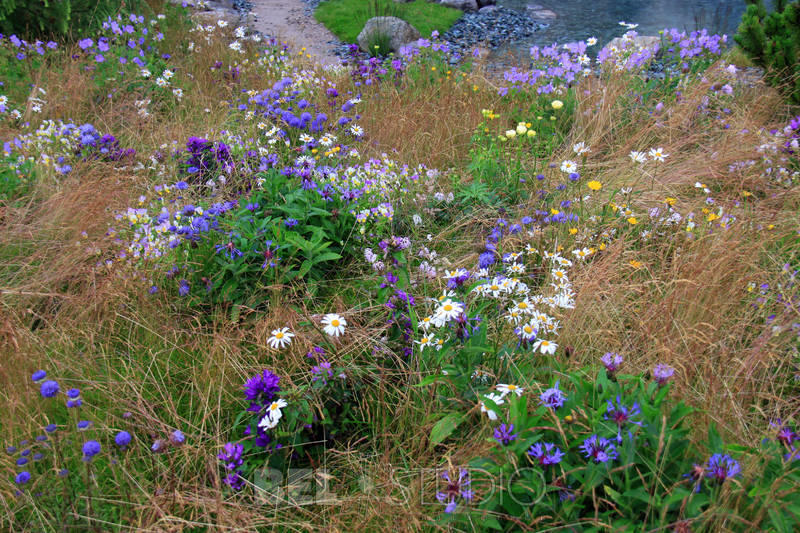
[314, 0, 462, 43]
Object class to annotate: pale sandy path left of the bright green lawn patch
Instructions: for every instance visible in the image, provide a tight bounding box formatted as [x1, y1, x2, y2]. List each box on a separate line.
[252, 0, 339, 65]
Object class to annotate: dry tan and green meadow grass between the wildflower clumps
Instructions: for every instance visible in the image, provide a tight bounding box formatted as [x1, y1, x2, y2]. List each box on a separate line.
[0, 2, 798, 531]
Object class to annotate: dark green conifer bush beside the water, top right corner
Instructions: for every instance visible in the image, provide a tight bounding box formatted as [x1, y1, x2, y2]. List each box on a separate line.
[734, 0, 800, 103]
